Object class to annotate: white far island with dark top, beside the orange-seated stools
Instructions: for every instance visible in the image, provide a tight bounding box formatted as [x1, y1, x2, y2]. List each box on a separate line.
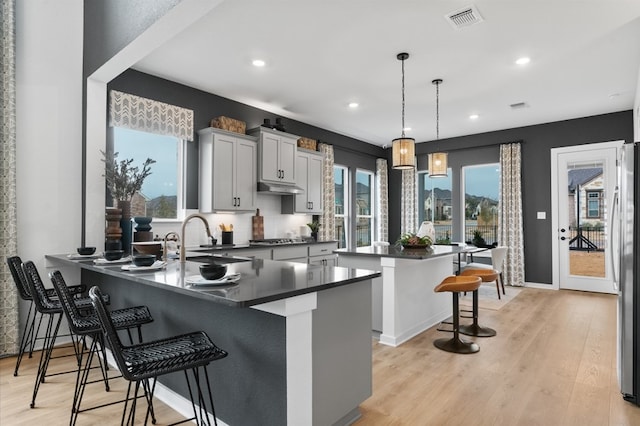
[334, 245, 468, 346]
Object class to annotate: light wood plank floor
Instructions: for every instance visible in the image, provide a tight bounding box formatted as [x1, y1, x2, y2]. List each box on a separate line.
[0, 288, 640, 426]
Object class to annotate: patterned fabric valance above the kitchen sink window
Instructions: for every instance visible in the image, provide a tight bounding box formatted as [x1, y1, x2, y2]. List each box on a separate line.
[109, 90, 193, 141]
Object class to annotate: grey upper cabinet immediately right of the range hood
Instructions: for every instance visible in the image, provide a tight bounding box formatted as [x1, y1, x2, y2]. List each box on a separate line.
[281, 149, 323, 214]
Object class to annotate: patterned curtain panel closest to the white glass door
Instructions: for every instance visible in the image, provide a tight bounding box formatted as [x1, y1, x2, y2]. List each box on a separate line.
[498, 143, 524, 286]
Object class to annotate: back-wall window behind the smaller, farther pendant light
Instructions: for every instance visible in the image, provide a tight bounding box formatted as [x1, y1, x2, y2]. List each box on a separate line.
[416, 169, 453, 244]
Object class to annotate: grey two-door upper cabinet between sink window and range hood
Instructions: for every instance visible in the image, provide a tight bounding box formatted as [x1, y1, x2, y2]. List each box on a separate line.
[198, 127, 257, 213]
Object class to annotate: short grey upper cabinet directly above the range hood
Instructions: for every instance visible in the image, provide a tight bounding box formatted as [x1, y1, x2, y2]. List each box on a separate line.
[249, 127, 298, 184]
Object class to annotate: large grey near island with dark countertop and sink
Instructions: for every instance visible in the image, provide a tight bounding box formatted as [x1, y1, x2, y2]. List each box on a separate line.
[46, 255, 380, 425]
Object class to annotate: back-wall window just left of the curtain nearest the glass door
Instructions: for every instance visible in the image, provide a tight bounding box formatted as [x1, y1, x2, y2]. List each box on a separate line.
[462, 164, 500, 245]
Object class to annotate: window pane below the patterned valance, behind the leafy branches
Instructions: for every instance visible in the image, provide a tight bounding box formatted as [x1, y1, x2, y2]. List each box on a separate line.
[113, 127, 184, 219]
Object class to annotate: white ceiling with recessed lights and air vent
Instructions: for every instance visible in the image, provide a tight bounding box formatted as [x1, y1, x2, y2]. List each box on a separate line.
[134, 0, 640, 146]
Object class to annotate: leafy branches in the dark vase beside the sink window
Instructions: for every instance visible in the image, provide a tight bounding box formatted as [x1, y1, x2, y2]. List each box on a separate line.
[100, 151, 155, 201]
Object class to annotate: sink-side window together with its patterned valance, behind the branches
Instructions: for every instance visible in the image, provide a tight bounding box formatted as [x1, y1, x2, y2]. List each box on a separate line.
[107, 90, 193, 219]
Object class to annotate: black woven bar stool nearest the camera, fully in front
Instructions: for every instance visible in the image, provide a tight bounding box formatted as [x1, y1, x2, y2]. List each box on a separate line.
[89, 286, 227, 425]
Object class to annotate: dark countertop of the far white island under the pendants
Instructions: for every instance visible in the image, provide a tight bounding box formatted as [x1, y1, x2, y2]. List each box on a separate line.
[333, 244, 485, 260]
